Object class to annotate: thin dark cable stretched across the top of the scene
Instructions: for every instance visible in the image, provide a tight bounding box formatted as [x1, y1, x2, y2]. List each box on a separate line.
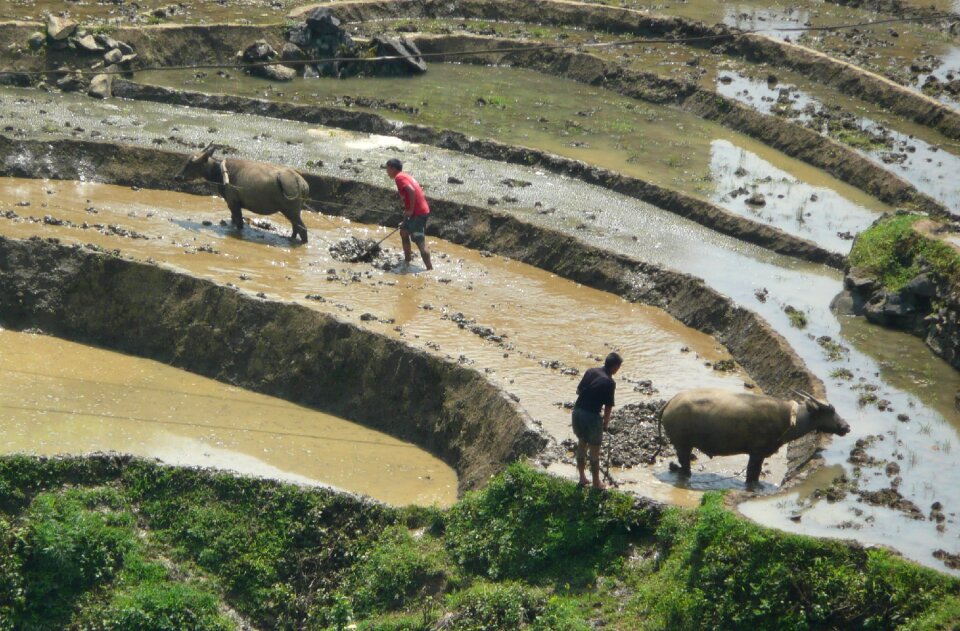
[0, 13, 956, 76]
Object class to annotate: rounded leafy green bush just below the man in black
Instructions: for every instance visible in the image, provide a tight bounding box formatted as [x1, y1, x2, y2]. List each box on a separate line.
[446, 463, 651, 584]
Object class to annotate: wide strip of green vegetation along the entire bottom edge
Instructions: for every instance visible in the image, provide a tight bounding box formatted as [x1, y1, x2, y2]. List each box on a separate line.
[0, 457, 960, 631]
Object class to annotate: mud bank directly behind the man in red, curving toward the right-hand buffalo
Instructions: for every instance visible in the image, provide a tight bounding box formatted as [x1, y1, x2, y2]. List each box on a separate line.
[0, 136, 824, 478]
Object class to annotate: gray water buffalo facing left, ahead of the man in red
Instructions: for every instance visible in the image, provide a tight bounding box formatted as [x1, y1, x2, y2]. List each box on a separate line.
[175, 145, 310, 243]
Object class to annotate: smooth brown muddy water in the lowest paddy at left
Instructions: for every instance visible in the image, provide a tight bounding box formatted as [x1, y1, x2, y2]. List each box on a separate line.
[0, 329, 457, 506]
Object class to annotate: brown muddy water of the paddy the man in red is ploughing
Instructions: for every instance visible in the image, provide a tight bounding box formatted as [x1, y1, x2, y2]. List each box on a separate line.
[0, 179, 752, 501]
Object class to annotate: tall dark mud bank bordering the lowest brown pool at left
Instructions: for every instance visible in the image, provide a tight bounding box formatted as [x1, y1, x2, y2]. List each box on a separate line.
[0, 238, 547, 492]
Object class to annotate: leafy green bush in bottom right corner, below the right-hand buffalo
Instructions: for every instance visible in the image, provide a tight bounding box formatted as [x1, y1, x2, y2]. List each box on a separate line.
[633, 494, 957, 630]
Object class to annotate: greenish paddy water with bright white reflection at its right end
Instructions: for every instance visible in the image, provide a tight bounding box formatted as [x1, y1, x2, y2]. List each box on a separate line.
[131, 64, 887, 252]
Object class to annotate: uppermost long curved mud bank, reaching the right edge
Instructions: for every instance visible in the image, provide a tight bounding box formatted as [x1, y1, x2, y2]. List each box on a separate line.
[290, 0, 960, 139]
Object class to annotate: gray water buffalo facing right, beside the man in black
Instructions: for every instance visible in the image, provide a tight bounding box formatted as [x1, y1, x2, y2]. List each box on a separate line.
[660, 388, 850, 484]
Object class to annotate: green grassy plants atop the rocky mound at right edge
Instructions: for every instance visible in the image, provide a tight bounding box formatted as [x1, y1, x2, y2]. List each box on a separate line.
[849, 214, 960, 291]
